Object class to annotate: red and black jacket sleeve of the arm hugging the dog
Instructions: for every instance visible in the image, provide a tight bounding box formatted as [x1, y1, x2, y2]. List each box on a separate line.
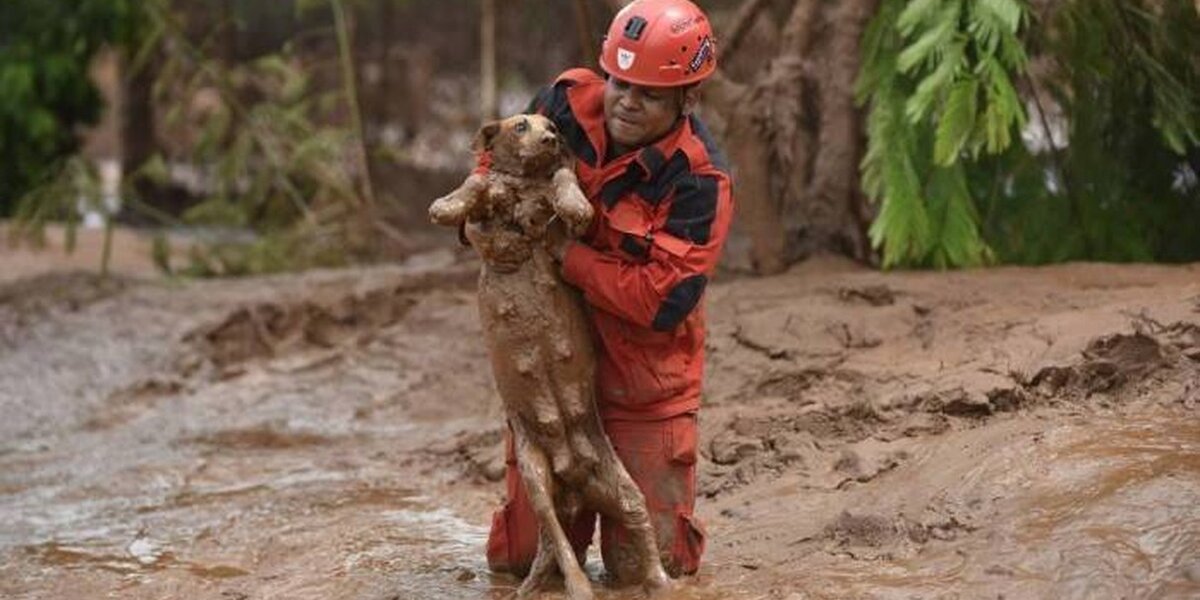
[563, 172, 733, 331]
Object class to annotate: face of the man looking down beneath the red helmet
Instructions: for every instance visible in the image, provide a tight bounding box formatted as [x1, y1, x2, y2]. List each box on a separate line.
[604, 77, 683, 151]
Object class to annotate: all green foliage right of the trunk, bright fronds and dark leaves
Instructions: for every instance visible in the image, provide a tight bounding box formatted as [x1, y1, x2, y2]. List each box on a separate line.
[858, 0, 1200, 268]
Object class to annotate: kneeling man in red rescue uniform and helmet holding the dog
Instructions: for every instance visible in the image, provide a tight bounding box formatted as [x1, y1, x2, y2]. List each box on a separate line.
[482, 0, 733, 578]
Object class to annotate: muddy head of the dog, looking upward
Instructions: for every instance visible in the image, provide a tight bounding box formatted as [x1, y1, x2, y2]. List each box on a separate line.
[475, 114, 569, 176]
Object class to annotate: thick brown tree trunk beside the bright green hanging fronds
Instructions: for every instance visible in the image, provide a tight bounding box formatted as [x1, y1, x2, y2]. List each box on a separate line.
[709, 0, 877, 275]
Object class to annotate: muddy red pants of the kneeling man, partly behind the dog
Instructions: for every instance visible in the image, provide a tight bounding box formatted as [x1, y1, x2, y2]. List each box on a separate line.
[487, 414, 704, 577]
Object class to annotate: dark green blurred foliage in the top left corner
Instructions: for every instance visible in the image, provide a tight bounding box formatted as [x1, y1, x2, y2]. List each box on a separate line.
[0, 0, 140, 217]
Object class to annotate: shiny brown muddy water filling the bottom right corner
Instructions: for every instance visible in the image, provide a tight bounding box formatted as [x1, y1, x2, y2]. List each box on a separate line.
[803, 414, 1200, 599]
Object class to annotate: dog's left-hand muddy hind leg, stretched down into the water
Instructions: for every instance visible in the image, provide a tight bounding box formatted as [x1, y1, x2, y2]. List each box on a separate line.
[512, 420, 593, 600]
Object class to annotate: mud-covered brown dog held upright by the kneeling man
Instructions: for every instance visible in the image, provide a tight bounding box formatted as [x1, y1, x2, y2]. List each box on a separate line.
[430, 115, 671, 600]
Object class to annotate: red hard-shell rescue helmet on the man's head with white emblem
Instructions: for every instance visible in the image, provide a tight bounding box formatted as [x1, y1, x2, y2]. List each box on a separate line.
[600, 0, 716, 88]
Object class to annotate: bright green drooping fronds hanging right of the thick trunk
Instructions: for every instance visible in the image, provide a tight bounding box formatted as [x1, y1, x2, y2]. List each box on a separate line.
[857, 0, 1028, 268]
